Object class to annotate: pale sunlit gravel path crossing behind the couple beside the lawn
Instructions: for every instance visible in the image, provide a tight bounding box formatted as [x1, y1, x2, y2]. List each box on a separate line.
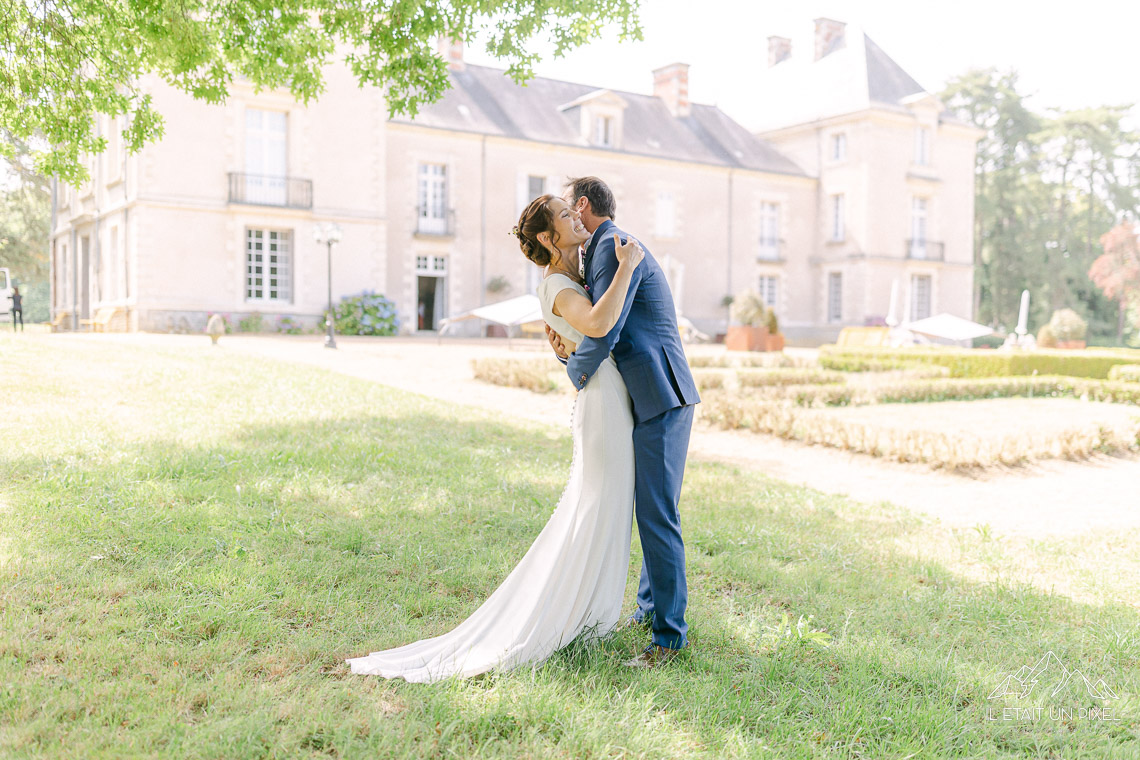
[98, 335, 1140, 537]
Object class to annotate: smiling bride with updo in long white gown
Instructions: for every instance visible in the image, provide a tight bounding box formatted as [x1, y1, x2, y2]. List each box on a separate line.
[347, 195, 644, 683]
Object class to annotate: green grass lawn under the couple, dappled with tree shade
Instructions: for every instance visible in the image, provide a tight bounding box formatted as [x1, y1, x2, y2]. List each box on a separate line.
[0, 335, 1140, 759]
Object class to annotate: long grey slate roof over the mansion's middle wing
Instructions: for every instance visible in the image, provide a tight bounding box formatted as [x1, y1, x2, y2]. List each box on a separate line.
[393, 64, 804, 175]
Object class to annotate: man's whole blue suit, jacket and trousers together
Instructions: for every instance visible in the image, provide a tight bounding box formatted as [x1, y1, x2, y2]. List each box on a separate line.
[567, 220, 701, 649]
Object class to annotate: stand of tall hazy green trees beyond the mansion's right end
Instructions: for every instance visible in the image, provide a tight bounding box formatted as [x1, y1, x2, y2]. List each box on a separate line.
[943, 68, 1140, 337]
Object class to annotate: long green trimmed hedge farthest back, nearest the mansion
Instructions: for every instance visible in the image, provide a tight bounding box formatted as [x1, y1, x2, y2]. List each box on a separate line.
[820, 346, 1140, 379]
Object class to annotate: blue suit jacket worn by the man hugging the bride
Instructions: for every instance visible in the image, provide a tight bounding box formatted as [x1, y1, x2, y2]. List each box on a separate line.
[567, 220, 701, 423]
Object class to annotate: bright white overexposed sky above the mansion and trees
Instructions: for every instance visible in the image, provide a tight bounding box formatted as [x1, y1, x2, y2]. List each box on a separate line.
[464, 0, 1140, 126]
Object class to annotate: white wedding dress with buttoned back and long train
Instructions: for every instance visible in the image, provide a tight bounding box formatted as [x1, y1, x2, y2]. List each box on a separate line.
[347, 275, 634, 683]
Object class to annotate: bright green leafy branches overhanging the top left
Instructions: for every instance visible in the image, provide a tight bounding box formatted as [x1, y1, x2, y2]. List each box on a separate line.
[0, 0, 641, 185]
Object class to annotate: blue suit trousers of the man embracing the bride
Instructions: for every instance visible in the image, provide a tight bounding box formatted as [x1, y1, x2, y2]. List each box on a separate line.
[634, 406, 694, 649]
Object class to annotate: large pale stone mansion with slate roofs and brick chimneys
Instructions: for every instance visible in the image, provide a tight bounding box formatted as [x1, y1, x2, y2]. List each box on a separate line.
[51, 19, 979, 344]
